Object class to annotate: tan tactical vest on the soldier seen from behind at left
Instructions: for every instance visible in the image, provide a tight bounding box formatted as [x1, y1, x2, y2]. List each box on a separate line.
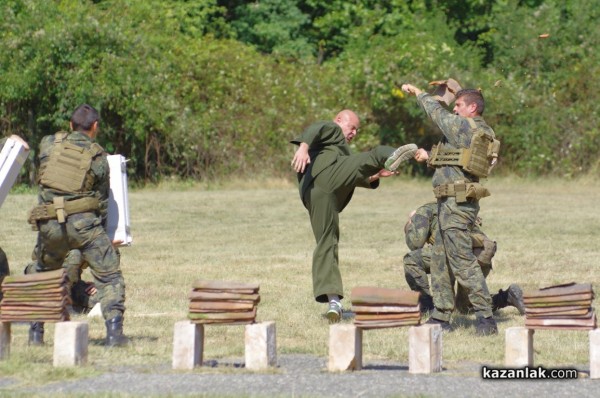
[39, 132, 102, 193]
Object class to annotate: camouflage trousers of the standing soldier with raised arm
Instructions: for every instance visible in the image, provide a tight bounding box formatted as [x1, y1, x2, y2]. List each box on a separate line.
[431, 197, 492, 321]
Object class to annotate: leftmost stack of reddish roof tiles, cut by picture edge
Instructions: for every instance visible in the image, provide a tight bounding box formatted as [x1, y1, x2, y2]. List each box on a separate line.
[0, 268, 72, 322]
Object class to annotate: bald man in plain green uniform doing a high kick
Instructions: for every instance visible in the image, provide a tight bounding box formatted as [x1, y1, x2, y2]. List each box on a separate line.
[291, 110, 417, 322]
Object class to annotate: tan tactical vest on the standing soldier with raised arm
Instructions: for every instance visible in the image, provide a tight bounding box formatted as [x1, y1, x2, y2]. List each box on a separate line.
[427, 118, 500, 178]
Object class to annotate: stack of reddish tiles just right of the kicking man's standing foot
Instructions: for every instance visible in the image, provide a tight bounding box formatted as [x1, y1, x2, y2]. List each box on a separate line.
[350, 286, 421, 329]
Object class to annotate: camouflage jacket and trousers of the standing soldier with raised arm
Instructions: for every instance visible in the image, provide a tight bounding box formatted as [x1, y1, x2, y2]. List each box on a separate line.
[417, 93, 495, 321]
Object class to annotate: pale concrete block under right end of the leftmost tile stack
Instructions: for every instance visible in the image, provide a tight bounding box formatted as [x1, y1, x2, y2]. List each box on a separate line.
[54, 322, 89, 366]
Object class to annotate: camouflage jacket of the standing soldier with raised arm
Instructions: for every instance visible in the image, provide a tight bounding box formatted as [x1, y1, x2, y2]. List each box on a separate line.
[417, 93, 495, 187]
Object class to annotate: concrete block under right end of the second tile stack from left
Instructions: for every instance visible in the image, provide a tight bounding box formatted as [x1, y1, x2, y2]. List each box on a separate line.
[244, 322, 277, 370]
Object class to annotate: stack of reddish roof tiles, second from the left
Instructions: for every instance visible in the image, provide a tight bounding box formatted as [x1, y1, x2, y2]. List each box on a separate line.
[188, 280, 260, 325]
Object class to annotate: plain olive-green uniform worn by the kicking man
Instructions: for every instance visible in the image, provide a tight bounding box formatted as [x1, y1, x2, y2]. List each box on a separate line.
[291, 121, 395, 302]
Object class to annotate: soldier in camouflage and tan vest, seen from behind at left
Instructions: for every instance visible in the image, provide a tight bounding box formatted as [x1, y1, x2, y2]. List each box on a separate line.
[25, 104, 128, 346]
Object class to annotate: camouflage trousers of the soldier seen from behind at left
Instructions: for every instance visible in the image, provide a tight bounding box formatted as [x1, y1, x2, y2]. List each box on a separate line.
[25, 212, 125, 319]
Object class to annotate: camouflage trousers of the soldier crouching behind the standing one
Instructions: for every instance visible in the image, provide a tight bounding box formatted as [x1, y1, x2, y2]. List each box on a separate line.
[404, 245, 492, 314]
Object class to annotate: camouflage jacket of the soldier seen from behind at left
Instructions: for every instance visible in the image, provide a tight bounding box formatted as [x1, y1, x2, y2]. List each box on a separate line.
[38, 131, 110, 224]
